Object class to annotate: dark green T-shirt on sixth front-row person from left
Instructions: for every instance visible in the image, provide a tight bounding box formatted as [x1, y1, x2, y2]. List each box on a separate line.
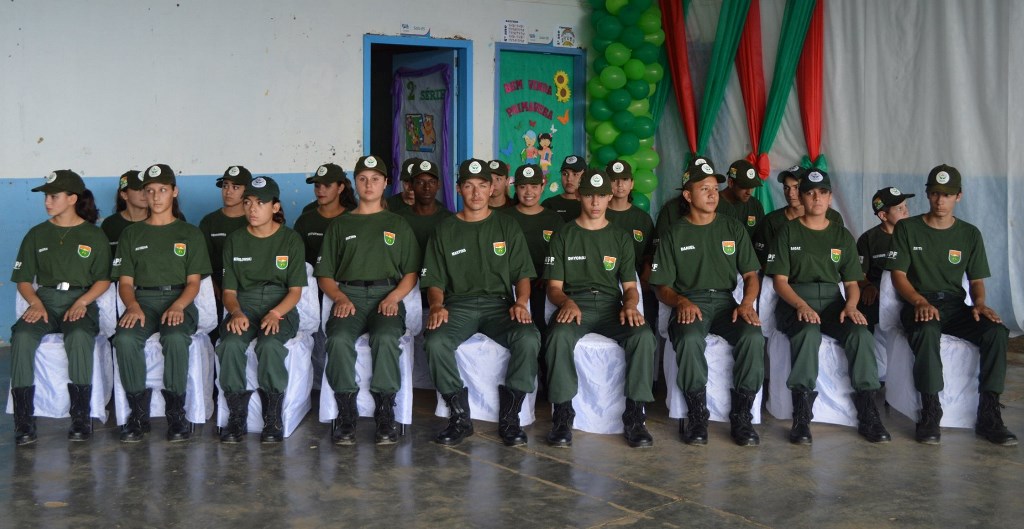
[544, 222, 637, 296]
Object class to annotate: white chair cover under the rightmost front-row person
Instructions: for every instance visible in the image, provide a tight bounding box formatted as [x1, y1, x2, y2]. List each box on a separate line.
[877, 271, 981, 428]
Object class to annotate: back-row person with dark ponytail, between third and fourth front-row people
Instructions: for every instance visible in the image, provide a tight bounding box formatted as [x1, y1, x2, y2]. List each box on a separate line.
[295, 164, 355, 264]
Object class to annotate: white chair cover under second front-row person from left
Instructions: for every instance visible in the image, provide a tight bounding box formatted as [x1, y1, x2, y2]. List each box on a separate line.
[114, 277, 217, 426]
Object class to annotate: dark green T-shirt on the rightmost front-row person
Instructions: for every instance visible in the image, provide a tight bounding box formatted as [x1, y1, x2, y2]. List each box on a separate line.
[887, 215, 991, 298]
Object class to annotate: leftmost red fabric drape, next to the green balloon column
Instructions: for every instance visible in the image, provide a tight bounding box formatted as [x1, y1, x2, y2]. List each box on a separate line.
[658, 0, 697, 152]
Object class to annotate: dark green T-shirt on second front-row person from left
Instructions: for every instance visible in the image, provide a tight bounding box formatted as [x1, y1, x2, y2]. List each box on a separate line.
[111, 220, 211, 286]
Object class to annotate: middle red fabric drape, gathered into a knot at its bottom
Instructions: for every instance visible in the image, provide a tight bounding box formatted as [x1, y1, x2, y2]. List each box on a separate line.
[736, 0, 771, 179]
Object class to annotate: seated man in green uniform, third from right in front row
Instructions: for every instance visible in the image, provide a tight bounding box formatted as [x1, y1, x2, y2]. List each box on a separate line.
[650, 162, 765, 446]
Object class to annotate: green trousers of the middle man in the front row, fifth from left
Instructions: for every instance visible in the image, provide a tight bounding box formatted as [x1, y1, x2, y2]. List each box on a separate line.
[424, 297, 541, 395]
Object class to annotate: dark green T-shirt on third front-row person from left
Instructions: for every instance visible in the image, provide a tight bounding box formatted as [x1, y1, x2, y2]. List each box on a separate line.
[221, 226, 308, 291]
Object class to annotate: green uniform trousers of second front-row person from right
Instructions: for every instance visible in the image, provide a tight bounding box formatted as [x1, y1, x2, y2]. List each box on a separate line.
[775, 282, 881, 391]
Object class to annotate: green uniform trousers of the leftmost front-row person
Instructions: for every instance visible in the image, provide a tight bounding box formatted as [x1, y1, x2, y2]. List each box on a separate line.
[10, 286, 99, 388]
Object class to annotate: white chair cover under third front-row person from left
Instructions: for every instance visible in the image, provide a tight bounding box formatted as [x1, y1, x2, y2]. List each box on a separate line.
[214, 263, 321, 437]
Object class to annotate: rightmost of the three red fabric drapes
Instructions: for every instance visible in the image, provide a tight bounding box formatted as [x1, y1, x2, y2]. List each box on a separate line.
[797, 0, 825, 164]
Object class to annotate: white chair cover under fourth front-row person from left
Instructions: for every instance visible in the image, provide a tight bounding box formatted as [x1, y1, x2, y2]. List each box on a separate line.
[319, 281, 423, 425]
